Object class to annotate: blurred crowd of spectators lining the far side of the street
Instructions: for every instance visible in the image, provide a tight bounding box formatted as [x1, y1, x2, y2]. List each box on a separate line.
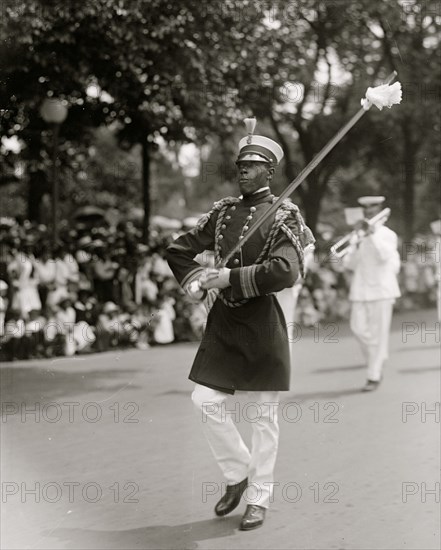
[0, 218, 439, 360]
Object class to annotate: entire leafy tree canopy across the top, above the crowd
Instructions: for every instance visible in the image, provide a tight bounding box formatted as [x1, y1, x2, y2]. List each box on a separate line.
[0, 0, 441, 237]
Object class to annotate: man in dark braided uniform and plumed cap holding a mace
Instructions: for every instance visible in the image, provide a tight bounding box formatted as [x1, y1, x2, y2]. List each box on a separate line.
[167, 119, 314, 530]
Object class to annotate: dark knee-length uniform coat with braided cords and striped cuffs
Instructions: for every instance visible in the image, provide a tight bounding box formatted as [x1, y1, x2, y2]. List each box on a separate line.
[167, 188, 314, 393]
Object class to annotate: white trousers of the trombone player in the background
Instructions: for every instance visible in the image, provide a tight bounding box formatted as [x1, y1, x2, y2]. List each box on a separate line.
[350, 299, 395, 381]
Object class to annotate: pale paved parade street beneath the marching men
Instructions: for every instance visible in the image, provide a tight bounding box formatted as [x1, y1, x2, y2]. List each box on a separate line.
[1, 310, 440, 550]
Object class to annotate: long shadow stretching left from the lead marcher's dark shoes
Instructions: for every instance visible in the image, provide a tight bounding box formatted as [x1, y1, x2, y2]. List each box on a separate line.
[43, 515, 241, 550]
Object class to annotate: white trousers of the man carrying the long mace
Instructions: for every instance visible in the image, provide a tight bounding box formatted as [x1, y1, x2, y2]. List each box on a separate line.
[192, 384, 279, 508]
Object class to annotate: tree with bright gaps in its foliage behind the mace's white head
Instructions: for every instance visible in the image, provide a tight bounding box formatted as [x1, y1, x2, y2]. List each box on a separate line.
[218, 0, 439, 234]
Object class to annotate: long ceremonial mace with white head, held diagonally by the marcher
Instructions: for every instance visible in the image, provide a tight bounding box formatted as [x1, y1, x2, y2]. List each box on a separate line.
[187, 71, 401, 295]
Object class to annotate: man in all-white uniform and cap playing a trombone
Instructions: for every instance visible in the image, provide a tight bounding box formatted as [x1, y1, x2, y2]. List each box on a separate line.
[344, 196, 400, 391]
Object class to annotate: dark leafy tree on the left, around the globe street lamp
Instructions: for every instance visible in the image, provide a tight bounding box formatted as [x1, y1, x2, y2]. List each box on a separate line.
[0, 0, 258, 236]
